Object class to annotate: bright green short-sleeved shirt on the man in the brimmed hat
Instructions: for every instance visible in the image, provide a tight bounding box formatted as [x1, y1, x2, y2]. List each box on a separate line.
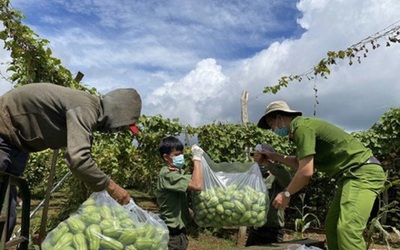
[290, 116, 372, 177]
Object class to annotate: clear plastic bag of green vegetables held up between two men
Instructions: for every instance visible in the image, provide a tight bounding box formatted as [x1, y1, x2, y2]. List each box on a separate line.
[192, 153, 269, 228]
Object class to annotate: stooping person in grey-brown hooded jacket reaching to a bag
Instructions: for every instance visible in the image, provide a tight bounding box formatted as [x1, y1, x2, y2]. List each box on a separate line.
[0, 83, 142, 238]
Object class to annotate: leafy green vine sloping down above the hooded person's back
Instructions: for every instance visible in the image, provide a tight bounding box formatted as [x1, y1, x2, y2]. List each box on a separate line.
[0, 0, 87, 90]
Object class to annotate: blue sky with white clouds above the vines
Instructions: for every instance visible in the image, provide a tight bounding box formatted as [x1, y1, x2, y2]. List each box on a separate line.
[0, 0, 400, 132]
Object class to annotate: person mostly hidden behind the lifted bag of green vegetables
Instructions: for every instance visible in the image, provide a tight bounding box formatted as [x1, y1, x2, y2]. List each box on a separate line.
[245, 143, 291, 246]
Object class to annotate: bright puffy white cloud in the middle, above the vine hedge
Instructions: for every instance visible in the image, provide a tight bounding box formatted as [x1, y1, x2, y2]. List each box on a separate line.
[144, 59, 230, 125]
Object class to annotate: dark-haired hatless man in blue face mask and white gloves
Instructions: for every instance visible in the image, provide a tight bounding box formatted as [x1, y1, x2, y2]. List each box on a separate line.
[157, 136, 203, 250]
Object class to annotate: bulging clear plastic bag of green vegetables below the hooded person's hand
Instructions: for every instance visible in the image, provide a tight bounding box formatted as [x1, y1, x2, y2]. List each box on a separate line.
[42, 191, 169, 250]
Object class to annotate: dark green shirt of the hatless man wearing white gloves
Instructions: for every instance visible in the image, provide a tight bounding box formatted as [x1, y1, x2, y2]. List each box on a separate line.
[157, 166, 192, 229]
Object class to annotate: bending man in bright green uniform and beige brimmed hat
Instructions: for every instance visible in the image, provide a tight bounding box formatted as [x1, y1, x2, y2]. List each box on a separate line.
[258, 101, 386, 250]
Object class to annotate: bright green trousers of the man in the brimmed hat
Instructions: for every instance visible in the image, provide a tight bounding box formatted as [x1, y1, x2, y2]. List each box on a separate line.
[325, 164, 386, 250]
